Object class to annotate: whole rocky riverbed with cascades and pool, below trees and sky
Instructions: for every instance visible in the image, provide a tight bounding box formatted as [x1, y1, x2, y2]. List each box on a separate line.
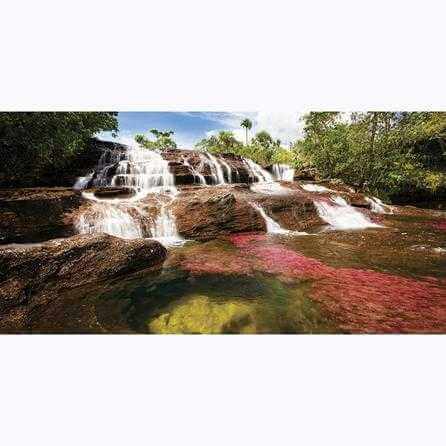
[0, 141, 446, 333]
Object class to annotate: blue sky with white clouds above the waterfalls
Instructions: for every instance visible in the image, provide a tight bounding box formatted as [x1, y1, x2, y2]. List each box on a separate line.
[99, 112, 301, 148]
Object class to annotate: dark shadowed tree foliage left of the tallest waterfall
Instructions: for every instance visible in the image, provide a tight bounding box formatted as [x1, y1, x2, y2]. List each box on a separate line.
[0, 112, 118, 186]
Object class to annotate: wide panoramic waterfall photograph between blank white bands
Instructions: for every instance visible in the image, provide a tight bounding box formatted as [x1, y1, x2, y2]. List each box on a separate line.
[0, 112, 446, 334]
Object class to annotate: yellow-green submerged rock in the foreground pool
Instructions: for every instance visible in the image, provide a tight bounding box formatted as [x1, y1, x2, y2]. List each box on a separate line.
[147, 295, 255, 334]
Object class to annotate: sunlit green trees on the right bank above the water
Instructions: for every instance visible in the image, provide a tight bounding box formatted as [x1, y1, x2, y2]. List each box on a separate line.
[295, 112, 446, 195]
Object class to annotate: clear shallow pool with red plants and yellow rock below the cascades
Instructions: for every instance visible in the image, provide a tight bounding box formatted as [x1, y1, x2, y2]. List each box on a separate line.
[26, 216, 446, 333]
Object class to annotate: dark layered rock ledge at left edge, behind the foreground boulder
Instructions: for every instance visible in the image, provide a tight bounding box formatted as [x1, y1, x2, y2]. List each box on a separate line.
[0, 187, 81, 244]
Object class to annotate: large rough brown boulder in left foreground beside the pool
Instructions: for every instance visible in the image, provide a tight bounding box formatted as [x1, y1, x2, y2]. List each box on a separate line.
[0, 234, 166, 318]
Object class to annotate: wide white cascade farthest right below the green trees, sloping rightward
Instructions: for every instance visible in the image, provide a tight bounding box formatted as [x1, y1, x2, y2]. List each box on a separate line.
[314, 196, 382, 230]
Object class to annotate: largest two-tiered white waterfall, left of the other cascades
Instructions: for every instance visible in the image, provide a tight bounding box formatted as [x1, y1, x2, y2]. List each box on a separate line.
[75, 146, 182, 245]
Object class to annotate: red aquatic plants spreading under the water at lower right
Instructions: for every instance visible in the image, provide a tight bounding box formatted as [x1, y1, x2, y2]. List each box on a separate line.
[230, 235, 446, 333]
